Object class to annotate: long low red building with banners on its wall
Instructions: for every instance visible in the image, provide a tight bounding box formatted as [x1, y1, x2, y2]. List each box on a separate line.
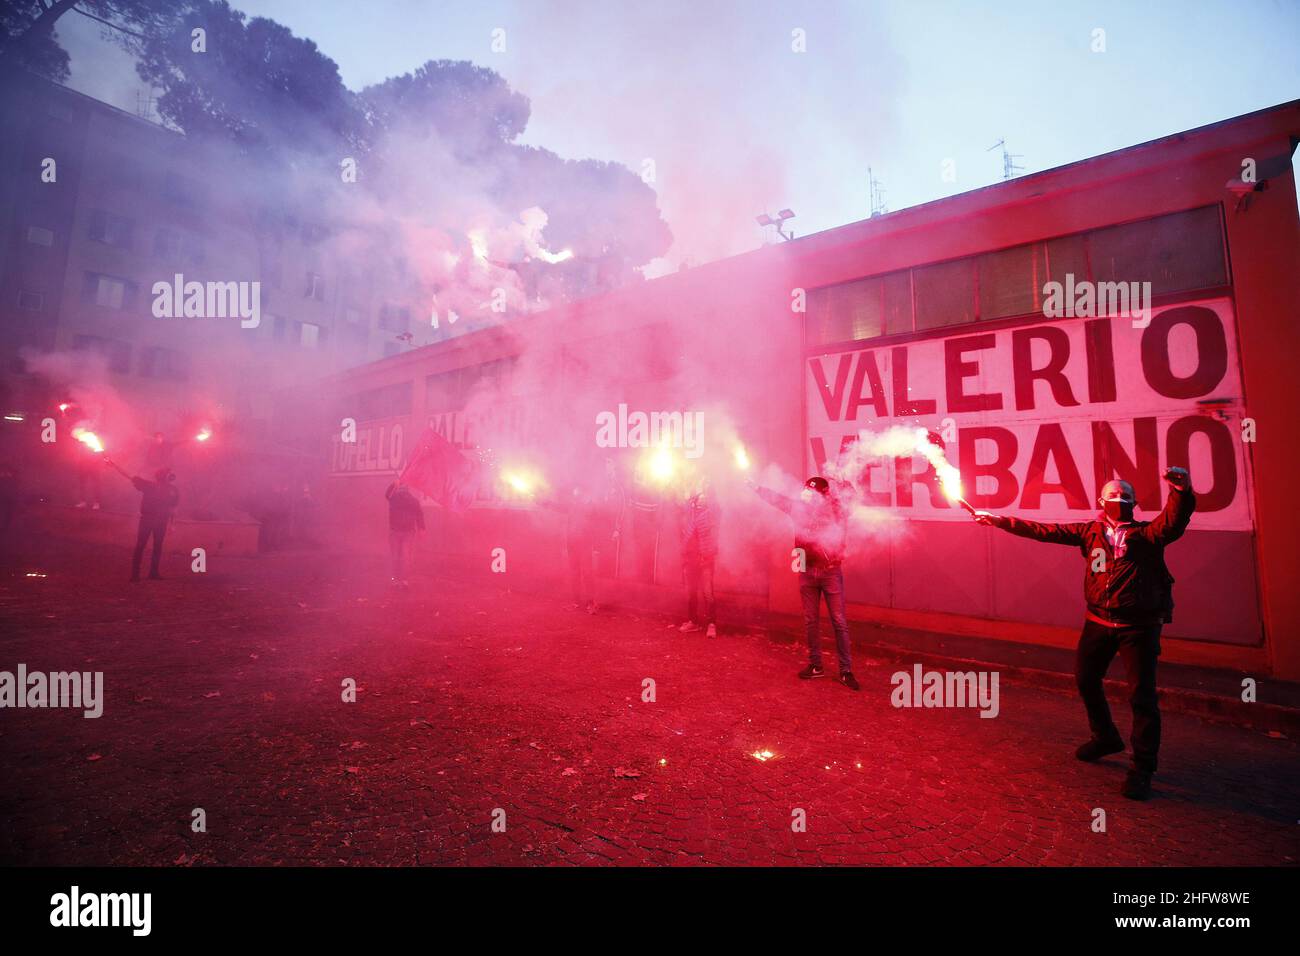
[326, 103, 1300, 679]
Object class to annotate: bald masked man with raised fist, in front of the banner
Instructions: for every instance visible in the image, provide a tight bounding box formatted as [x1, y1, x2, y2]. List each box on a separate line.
[975, 468, 1196, 800]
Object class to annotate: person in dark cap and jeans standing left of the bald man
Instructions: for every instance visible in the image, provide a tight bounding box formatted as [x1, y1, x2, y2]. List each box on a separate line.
[750, 475, 859, 691]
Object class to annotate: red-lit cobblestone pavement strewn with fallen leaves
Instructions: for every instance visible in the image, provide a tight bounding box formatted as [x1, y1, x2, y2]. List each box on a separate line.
[0, 546, 1300, 865]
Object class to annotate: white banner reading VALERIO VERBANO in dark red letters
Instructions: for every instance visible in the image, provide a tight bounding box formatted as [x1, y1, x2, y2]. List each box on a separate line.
[805, 299, 1253, 531]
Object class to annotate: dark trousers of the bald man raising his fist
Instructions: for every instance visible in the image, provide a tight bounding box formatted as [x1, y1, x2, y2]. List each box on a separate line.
[1074, 620, 1161, 774]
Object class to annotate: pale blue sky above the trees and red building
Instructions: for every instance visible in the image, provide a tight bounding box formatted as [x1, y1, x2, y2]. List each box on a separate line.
[60, 0, 1300, 274]
